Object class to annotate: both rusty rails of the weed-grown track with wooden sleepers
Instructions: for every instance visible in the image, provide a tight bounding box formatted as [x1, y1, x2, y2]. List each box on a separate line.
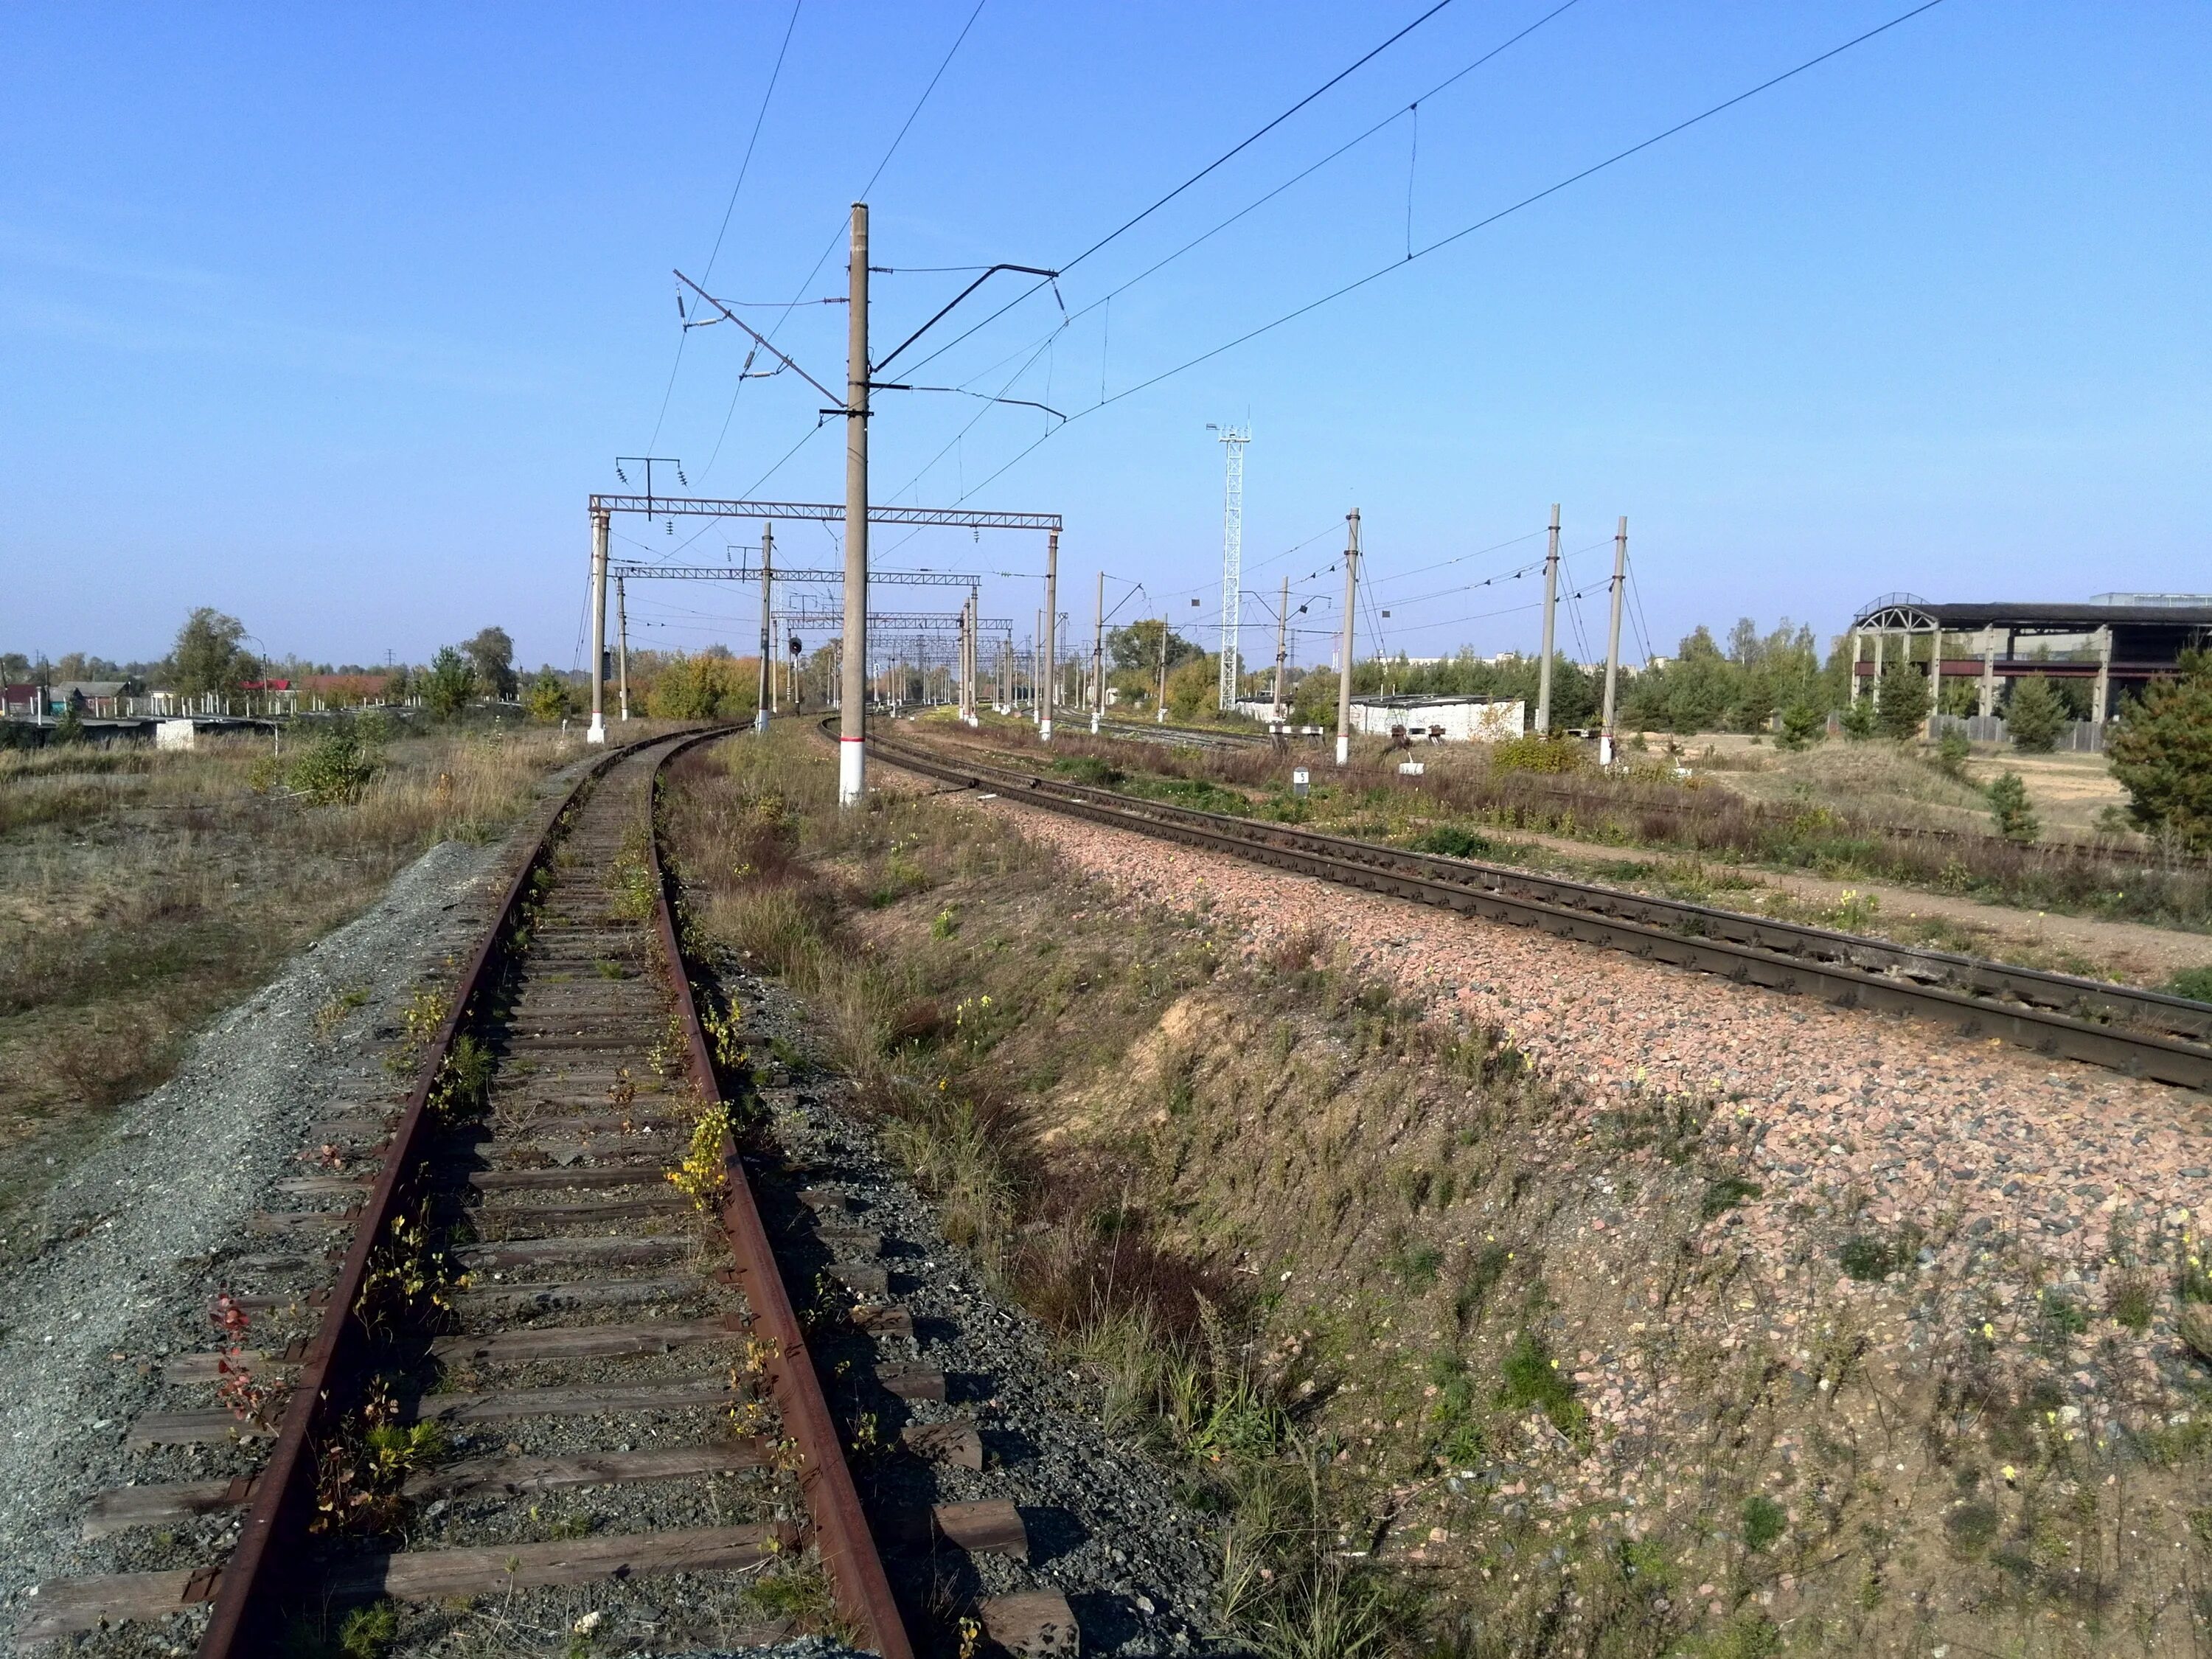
[199, 728, 914, 1659]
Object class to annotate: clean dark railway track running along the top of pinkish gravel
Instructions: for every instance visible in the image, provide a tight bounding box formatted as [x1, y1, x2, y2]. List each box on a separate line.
[869, 739, 2212, 1088]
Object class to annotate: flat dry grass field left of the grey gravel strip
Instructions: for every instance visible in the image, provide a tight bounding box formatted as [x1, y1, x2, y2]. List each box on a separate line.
[0, 730, 606, 1225]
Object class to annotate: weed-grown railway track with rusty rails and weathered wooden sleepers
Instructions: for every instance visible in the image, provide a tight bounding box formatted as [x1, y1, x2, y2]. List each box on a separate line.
[15, 732, 1075, 1659]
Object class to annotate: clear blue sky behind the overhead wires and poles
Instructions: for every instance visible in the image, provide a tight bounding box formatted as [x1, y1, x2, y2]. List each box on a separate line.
[0, 0, 2212, 666]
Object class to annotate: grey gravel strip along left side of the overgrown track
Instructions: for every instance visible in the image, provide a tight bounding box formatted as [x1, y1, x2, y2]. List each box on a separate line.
[0, 843, 504, 1639]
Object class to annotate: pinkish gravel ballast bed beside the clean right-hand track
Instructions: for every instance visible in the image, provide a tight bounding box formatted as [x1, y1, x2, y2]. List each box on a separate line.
[984, 801, 2212, 1413]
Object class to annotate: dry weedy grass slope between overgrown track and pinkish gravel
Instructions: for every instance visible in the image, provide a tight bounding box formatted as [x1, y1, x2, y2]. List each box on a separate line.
[670, 734, 2212, 1659]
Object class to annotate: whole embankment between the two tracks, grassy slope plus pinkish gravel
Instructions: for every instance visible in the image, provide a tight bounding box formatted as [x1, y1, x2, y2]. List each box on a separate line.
[677, 730, 2212, 1655]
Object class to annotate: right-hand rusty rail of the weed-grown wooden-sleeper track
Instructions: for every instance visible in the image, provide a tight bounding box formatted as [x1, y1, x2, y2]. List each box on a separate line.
[646, 732, 914, 1659]
